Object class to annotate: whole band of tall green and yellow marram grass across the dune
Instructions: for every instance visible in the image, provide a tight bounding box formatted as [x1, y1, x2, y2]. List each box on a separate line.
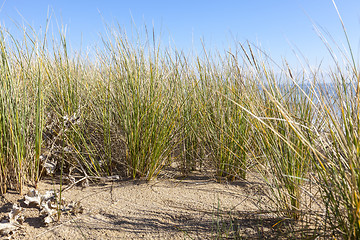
[0, 19, 360, 239]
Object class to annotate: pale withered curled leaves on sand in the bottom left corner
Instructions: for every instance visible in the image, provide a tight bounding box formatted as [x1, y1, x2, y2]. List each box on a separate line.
[0, 203, 24, 235]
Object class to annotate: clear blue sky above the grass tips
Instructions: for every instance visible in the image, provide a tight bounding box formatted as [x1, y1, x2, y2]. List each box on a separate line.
[0, 0, 360, 69]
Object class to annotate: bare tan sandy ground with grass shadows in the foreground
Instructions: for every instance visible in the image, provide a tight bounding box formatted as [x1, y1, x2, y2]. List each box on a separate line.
[0, 173, 286, 240]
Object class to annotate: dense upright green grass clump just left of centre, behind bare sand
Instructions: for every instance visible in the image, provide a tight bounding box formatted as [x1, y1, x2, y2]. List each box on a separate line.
[108, 30, 181, 180]
